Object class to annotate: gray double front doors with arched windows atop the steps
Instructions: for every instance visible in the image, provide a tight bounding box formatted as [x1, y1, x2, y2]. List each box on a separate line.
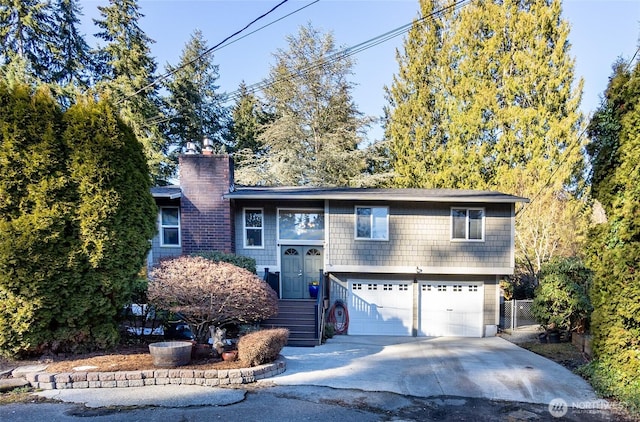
[280, 246, 322, 299]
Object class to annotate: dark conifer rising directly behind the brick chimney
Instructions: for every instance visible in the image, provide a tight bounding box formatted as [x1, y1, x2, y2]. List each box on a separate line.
[164, 30, 229, 173]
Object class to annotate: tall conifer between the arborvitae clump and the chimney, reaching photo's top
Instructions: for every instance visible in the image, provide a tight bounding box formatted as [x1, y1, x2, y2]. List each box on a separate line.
[94, 0, 172, 183]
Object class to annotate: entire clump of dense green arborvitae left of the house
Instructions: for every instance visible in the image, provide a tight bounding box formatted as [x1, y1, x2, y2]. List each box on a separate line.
[0, 84, 156, 356]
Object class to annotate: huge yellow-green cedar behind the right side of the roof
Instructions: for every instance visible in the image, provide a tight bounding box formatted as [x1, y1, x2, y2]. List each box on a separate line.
[385, 0, 584, 278]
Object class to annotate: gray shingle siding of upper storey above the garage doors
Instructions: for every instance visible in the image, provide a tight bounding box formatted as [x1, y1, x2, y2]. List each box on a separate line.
[328, 202, 513, 267]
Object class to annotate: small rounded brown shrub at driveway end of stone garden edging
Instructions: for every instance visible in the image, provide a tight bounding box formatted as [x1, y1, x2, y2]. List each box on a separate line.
[238, 328, 289, 366]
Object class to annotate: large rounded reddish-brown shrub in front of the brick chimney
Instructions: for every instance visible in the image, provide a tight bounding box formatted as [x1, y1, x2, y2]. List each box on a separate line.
[147, 256, 278, 342]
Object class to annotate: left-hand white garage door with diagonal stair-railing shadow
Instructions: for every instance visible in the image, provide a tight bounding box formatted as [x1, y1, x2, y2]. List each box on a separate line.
[348, 280, 413, 336]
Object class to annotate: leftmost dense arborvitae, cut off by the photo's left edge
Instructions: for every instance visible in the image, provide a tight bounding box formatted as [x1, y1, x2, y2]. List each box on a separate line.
[0, 82, 70, 356]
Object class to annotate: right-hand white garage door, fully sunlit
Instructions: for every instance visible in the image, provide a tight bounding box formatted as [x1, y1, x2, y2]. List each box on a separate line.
[418, 282, 484, 337]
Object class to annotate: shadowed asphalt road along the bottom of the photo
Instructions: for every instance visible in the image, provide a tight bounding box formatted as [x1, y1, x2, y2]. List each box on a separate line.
[0, 385, 621, 422]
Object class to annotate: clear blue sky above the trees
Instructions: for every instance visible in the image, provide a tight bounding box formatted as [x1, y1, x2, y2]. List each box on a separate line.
[80, 0, 640, 140]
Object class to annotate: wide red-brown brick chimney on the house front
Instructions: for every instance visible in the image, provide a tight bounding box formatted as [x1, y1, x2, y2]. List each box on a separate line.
[179, 153, 235, 255]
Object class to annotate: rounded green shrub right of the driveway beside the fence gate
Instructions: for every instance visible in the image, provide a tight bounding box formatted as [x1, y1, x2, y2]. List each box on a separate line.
[531, 258, 593, 329]
